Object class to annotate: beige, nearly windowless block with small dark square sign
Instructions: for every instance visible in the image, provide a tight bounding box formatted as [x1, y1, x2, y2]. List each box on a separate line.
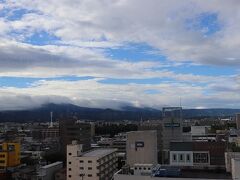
[126, 130, 158, 167]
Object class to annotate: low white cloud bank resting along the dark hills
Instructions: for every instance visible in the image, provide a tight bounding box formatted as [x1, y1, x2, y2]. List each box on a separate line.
[0, 79, 240, 109]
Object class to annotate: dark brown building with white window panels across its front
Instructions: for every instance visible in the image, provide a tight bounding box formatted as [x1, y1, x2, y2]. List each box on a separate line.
[170, 141, 226, 169]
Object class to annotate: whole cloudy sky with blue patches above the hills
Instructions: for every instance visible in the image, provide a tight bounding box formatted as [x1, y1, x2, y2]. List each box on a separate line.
[0, 0, 240, 110]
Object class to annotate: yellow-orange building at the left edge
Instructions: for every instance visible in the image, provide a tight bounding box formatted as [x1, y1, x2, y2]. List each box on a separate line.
[0, 142, 20, 170]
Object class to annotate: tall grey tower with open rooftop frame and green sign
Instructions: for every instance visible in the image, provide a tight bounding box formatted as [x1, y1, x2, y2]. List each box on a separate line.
[162, 107, 182, 151]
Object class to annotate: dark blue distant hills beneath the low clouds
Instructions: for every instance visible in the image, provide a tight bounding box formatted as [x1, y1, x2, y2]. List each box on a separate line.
[0, 104, 240, 122]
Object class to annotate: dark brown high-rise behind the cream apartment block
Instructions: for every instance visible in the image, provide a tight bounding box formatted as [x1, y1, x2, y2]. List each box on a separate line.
[59, 119, 91, 153]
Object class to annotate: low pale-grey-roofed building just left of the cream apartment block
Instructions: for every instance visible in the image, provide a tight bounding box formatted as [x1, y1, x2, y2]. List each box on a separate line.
[37, 161, 63, 180]
